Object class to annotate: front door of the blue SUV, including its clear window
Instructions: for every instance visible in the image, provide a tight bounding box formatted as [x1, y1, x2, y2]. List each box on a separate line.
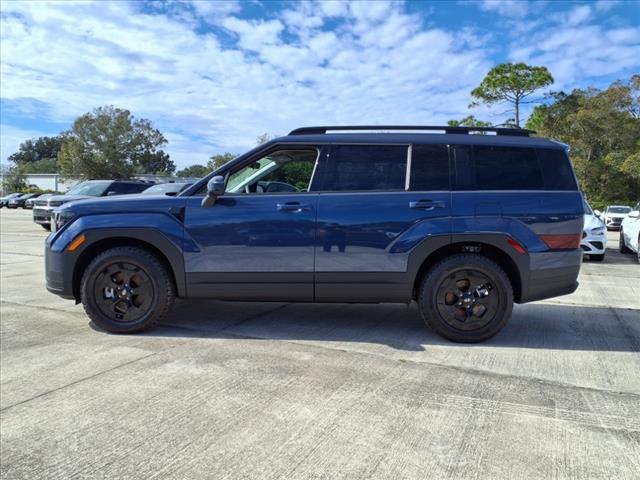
[185, 147, 319, 301]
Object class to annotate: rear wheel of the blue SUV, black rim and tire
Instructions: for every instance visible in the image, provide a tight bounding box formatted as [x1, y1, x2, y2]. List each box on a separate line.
[418, 254, 513, 343]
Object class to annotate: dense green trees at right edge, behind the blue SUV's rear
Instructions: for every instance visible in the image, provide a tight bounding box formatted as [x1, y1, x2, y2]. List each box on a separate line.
[527, 75, 640, 203]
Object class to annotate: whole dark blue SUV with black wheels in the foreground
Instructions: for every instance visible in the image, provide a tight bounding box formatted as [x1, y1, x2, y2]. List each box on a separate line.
[46, 126, 584, 342]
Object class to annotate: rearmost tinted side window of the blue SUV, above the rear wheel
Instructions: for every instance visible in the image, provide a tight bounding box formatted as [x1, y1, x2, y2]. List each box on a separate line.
[473, 146, 544, 190]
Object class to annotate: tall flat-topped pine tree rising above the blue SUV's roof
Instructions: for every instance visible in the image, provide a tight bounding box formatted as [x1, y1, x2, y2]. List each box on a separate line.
[470, 63, 553, 128]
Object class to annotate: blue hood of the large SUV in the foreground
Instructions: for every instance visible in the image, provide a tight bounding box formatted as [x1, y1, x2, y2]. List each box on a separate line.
[60, 195, 187, 215]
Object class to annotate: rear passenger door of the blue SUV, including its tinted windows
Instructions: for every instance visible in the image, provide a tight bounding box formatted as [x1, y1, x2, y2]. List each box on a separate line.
[315, 145, 451, 301]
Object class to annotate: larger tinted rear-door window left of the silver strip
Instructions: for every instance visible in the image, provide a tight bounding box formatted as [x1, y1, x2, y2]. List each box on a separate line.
[322, 145, 407, 191]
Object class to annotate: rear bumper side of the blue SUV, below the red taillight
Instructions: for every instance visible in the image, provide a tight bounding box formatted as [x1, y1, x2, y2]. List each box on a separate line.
[519, 249, 582, 303]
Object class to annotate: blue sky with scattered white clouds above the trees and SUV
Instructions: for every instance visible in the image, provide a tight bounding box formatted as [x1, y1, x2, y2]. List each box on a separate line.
[0, 0, 640, 167]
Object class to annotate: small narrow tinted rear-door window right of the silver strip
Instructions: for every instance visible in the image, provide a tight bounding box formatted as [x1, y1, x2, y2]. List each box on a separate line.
[410, 145, 449, 190]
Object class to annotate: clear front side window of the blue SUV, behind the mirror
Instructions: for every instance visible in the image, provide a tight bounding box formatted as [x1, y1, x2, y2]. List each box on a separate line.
[226, 149, 318, 194]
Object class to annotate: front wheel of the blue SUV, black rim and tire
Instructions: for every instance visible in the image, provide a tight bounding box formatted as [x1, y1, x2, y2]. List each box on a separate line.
[80, 247, 175, 333]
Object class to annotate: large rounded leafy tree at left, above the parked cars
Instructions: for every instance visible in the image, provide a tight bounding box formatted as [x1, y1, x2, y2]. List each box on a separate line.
[58, 105, 170, 178]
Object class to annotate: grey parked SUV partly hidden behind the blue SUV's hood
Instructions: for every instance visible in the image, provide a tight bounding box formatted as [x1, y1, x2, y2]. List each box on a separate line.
[33, 180, 154, 230]
